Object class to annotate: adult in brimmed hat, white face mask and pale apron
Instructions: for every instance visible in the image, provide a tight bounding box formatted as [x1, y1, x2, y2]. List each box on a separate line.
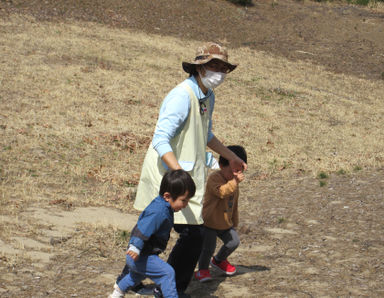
[118, 43, 247, 296]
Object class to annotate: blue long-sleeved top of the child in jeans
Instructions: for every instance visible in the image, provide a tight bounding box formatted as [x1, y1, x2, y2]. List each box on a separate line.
[129, 196, 174, 254]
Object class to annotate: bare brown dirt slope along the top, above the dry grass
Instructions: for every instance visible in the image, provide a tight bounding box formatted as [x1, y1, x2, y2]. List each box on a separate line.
[0, 0, 384, 80]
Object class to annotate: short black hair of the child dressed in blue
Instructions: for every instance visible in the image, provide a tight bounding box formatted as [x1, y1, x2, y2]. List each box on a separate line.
[159, 170, 196, 200]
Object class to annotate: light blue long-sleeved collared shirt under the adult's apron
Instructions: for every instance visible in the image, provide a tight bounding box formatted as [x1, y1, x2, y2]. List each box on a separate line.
[152, 76, 215, 157]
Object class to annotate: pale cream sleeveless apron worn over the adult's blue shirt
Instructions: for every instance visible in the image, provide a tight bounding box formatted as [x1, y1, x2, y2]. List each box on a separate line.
[134, 82, 210, 225]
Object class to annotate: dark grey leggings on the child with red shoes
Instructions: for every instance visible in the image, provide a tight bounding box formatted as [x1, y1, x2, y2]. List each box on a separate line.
[199, 227, 240, 270]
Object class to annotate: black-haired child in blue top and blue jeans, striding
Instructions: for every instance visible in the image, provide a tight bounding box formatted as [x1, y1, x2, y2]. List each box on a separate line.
[109, 170, 196, 298]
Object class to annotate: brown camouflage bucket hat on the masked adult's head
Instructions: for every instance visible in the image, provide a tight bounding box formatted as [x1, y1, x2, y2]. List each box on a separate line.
[182, 42, 237, 73]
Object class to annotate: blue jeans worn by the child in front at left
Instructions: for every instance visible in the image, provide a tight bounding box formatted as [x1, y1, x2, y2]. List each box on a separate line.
[117, 255, 178, 298]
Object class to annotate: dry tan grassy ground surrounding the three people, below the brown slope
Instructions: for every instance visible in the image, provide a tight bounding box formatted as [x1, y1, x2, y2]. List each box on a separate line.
[0, 1, 384, 297]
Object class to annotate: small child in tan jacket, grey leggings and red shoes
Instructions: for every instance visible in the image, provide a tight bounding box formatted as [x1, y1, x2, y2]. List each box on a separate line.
[195, 146, 247, 282]
